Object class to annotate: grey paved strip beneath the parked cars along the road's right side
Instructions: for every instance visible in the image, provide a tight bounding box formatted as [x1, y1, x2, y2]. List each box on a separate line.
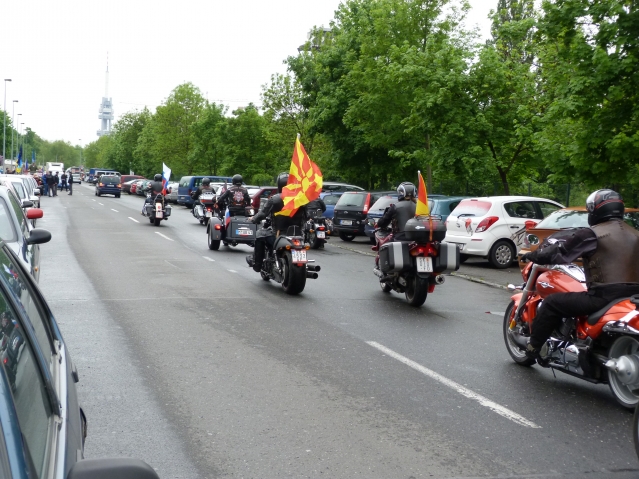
[326, 236, 524, 288]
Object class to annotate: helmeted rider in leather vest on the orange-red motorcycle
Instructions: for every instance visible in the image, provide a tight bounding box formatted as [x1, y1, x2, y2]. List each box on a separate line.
[522, 189, 639, 366]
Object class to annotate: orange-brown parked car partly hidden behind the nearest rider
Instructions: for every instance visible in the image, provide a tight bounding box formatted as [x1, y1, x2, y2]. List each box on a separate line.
[518, 206, 639, 269]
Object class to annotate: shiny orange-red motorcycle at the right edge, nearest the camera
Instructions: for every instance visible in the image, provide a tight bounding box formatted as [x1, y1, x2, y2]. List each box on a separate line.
[503, 263, 639, 408]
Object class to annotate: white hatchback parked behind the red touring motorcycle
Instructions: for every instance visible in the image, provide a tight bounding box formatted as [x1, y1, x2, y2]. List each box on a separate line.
[444, 196, 563, 269]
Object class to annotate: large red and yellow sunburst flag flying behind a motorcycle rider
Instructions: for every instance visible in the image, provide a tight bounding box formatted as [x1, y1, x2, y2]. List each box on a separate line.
[275, 135, 323, 216]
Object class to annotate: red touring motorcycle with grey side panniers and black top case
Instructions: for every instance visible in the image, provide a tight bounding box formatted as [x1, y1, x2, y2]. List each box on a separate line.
[369, 218, 459, 307]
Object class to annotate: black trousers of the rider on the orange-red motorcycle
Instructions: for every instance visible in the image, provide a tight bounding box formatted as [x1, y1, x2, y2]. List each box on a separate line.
[530, 292, 615, 349]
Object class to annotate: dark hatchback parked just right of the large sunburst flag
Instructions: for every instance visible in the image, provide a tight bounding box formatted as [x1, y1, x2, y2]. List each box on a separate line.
[333, 191, 395, 241]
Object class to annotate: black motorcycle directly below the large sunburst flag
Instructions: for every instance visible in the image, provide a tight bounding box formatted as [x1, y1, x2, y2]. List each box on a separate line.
[255, 226, 321, 295]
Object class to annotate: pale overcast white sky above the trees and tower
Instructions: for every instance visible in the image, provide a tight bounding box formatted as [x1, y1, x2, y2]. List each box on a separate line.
[0, 0, 497, 150]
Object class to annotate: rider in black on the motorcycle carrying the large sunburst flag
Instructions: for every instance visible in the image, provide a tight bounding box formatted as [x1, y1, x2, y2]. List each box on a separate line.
[246, 173, 306, 273]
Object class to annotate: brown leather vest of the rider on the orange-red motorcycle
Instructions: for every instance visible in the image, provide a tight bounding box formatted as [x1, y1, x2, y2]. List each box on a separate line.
[583, 220, 639, 287]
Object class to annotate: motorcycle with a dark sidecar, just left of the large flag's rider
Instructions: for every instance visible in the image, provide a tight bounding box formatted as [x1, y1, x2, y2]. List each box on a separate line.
[206, 206, 257, 251]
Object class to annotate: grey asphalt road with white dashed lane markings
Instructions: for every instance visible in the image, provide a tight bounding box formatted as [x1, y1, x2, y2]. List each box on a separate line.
[38, 185, 639, 478]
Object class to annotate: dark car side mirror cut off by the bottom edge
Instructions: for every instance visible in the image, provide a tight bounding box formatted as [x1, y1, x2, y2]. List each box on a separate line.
[67, 457, 160, 479]
